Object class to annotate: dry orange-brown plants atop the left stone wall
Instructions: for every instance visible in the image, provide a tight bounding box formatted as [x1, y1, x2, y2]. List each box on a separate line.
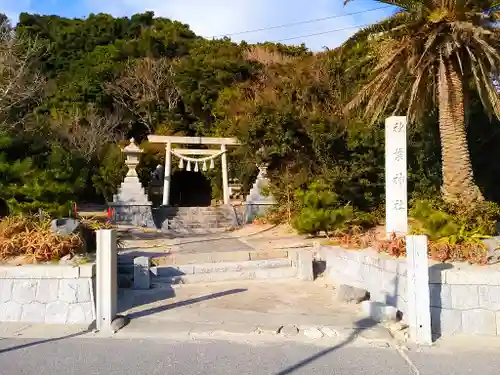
[0, 215, 83, 263]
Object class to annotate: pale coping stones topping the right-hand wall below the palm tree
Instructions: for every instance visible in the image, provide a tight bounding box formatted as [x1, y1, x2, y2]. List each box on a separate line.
[316, 245, 500, 286]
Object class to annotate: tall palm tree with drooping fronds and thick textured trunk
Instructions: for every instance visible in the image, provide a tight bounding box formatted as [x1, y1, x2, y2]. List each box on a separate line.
[346, 0, 500, 203]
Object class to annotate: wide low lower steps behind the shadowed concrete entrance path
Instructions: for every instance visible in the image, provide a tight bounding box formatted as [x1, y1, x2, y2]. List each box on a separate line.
[118, 250, 298, 288]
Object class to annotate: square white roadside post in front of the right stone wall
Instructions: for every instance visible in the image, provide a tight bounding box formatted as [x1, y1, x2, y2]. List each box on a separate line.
[406, 236, 432, 345]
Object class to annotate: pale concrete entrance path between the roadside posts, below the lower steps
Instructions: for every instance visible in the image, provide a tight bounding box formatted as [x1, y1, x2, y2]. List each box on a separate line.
[114, 280, 391, 341]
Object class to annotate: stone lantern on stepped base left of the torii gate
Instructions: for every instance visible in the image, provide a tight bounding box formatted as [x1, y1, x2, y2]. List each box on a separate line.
[109, 138, 154, 227]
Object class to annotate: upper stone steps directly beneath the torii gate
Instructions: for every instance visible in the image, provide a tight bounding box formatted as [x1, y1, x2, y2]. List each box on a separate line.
[156, 205, 240, 234]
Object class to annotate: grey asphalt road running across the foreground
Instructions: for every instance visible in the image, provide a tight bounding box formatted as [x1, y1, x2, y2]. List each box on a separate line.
[0, 338, 500, 375]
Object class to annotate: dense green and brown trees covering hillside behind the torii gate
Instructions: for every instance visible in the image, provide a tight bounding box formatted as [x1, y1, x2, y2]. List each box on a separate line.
[0, 9, 500, 223]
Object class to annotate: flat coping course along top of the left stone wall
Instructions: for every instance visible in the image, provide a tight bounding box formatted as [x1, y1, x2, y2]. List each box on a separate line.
[0, 263, 95, 279]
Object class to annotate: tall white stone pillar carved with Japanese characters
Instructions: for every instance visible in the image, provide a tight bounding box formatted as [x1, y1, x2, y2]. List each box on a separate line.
[385, 116, 408, 236]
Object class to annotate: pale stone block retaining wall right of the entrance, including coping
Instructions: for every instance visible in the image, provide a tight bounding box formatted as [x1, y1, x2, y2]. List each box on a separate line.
[318, 246, 500, 336]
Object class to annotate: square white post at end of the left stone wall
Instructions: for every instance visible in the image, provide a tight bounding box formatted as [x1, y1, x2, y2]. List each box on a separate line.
[96, 229, 118, 331]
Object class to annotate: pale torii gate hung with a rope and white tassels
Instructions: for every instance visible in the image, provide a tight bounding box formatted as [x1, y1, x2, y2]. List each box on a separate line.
[148, 135, 240, 206]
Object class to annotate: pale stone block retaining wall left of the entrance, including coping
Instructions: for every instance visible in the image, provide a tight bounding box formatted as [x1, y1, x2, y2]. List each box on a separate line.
[0, 264, 96, 324]
